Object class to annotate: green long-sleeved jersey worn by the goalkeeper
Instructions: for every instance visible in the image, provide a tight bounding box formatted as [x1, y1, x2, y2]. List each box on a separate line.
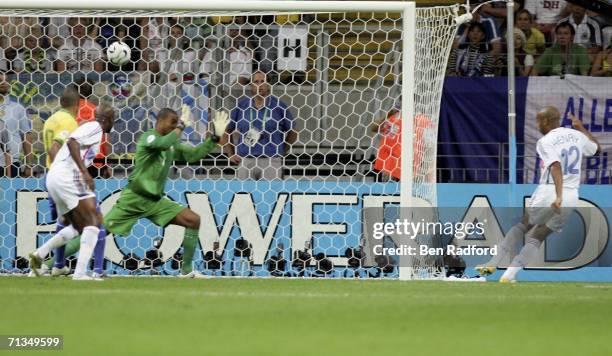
[127, 129, 216, 200]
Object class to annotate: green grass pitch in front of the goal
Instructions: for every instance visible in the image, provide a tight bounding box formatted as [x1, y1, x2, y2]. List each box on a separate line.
[0, 277, 612, 356]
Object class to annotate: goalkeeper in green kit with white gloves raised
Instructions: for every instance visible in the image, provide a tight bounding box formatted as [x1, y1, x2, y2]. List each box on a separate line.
[104, 106, 229, 278]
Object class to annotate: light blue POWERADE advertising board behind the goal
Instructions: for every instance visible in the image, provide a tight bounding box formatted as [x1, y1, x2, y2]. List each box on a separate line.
[0, 178, 612, 281]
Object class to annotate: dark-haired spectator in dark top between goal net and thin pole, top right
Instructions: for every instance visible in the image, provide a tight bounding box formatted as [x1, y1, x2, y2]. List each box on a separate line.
[447, 22, 494, 77]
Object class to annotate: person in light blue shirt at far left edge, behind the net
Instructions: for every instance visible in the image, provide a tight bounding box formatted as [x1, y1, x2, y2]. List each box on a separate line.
[0, 72, 34, 177]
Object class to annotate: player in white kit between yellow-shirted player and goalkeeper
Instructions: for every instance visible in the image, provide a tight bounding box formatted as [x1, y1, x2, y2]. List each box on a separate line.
[29, 105, 115, 280]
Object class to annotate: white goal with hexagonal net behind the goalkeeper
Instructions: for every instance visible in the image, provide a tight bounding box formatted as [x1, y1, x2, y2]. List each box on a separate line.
[0, 1, 457, 279]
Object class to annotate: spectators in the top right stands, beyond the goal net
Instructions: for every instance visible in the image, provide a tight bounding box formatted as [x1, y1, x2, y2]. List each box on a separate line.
[447, 0, 612, 77]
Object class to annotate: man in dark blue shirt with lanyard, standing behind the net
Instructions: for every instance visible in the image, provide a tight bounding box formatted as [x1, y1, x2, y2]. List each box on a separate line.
[227, 71, 297, 180]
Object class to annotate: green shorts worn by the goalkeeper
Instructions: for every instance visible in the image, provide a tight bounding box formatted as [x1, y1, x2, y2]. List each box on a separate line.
[104, 188, 185, 236]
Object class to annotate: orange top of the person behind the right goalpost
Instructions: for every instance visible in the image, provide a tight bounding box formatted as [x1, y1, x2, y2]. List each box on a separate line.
[374, 111, 433, 180]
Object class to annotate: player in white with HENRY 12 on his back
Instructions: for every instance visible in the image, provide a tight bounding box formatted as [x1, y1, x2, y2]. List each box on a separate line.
[476, 106, 600, 283]
